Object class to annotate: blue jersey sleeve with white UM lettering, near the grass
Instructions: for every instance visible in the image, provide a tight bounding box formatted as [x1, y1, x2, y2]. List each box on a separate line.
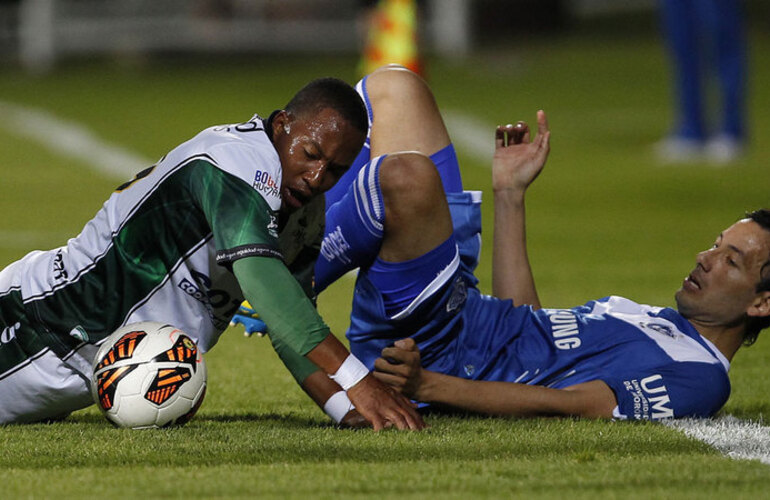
[604, 362, 730, 420]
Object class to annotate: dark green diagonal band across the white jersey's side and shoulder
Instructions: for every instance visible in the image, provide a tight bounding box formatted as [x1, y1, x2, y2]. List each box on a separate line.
[28, 159, 277, 355]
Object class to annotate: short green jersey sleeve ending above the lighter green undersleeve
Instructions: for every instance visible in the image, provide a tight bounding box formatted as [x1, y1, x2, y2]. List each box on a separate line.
[189, 160, 282, 265]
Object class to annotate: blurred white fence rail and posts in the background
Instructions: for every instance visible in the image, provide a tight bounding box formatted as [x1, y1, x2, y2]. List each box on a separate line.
[18, 0, 471, 72]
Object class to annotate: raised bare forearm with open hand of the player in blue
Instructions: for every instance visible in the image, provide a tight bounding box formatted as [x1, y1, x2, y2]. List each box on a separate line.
[492, 110, 551, 309]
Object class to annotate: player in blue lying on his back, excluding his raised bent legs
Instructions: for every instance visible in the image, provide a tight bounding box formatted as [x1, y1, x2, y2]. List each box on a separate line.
[368, 116, 770, 420]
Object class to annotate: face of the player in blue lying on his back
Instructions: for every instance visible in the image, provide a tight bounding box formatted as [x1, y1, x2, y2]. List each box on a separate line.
[676, 219, 770, 326]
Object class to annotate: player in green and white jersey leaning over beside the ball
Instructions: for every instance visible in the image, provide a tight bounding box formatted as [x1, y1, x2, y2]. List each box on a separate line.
[0, 79, 423, 429]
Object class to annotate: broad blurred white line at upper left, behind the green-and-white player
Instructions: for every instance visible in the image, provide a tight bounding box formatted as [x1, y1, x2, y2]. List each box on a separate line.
[0, 101, 152, 179]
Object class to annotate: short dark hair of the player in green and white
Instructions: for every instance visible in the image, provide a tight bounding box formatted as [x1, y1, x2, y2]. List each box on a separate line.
[286, 77, 369, 135]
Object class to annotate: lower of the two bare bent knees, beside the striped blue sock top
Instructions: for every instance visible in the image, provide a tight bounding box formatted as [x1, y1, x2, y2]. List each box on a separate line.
[380, 151, 446, 214]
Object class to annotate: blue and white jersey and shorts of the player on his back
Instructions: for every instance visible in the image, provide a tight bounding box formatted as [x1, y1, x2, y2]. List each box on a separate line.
[348, 284, 730, 420]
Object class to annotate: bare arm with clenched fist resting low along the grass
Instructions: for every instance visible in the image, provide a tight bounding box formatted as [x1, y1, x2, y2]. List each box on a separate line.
[374, 338, 617, 418]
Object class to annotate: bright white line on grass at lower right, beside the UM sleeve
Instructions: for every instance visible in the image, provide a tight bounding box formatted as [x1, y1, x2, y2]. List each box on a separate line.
[666, 415, 770, 465]
